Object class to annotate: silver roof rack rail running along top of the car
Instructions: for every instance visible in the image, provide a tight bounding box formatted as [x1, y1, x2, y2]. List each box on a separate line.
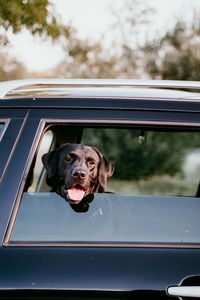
[0, 78, 200, 98]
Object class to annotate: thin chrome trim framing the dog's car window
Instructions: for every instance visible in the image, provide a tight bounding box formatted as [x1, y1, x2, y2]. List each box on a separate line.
[2, 118, 200, 249]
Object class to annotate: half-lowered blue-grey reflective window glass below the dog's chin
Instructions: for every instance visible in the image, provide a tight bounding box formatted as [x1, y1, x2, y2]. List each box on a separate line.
[11, 193, 200, 243]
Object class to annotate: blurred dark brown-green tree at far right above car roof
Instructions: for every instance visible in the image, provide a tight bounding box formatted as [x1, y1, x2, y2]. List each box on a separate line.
[142, 16, 200, 80]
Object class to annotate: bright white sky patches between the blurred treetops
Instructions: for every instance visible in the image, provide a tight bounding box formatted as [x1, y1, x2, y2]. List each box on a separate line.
[4, 0, 200, 72]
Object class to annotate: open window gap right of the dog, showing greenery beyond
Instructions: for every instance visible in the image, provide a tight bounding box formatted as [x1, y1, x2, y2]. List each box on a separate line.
[82, 128, 200, 196]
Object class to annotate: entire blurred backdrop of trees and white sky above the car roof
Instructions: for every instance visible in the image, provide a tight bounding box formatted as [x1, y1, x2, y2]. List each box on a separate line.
[0, 0, 200, 81]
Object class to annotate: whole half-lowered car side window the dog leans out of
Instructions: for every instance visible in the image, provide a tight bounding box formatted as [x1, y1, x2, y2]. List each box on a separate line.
[6, 125, 200, 243]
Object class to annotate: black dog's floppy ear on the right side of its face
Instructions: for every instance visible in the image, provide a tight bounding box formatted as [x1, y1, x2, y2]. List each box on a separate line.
[93, 147, 114, 187]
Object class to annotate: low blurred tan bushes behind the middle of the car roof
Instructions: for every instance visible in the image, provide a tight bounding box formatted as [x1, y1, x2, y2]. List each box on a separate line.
[50, 31, 121, 78]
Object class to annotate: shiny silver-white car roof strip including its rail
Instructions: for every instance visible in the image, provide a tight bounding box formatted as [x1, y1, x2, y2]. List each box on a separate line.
[0, 79, 200, 100]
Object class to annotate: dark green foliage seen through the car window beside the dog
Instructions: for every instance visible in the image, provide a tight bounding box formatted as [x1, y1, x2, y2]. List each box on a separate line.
[82, 129, 200, 180]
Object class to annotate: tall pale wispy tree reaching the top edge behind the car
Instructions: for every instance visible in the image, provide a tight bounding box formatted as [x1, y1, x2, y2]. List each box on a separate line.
[113, 0, 155, 78]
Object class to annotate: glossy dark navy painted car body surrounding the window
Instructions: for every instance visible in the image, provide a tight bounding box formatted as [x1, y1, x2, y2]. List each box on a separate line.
[0, 79, 200, 299]
